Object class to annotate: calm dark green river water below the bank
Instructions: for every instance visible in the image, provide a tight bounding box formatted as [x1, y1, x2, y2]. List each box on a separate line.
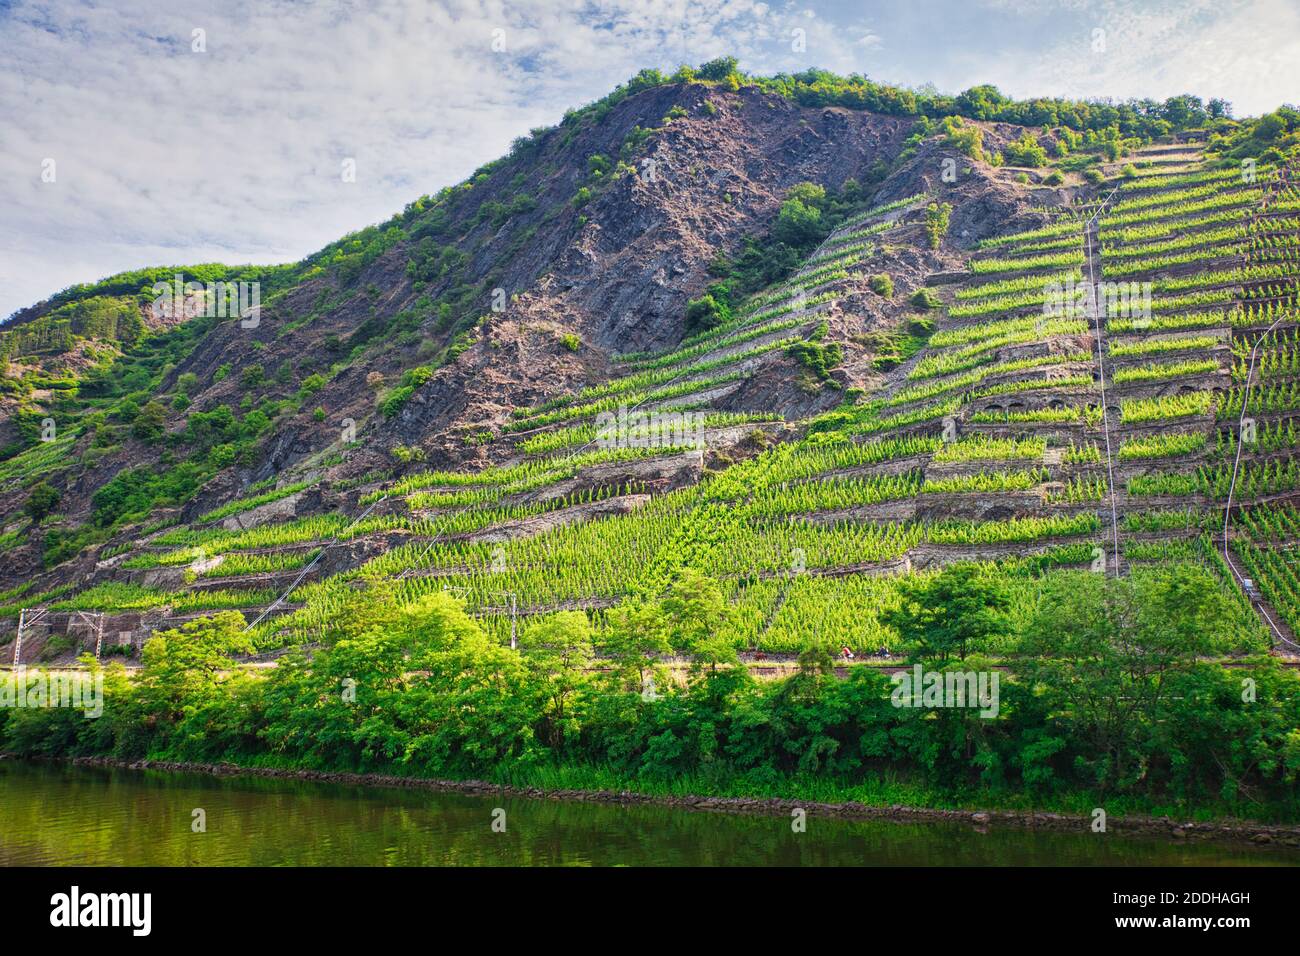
[0, 761, 1300, 866]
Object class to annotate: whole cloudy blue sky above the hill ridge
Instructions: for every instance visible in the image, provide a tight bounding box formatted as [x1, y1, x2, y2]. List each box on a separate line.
[0, 0, 1300, 317]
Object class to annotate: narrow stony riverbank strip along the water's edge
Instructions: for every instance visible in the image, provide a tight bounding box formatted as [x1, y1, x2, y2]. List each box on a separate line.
[27, 754, 1300, 848]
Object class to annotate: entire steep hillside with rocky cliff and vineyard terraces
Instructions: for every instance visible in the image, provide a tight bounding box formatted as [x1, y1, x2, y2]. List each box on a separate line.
[0, 65, 1300, 663]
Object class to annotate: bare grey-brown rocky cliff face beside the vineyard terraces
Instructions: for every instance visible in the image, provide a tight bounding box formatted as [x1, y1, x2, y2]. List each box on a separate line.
[0, 83, 1041, 598]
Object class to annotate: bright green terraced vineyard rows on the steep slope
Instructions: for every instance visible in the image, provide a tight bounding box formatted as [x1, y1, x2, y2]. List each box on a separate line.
[0, 140, 1300, 671]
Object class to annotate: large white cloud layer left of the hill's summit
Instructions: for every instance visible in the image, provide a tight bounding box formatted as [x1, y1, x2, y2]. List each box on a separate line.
[0, 0, 883, 316]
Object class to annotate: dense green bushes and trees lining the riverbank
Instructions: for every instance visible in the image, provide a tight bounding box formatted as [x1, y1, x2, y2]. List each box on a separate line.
[10, 566, 1300, 817]
